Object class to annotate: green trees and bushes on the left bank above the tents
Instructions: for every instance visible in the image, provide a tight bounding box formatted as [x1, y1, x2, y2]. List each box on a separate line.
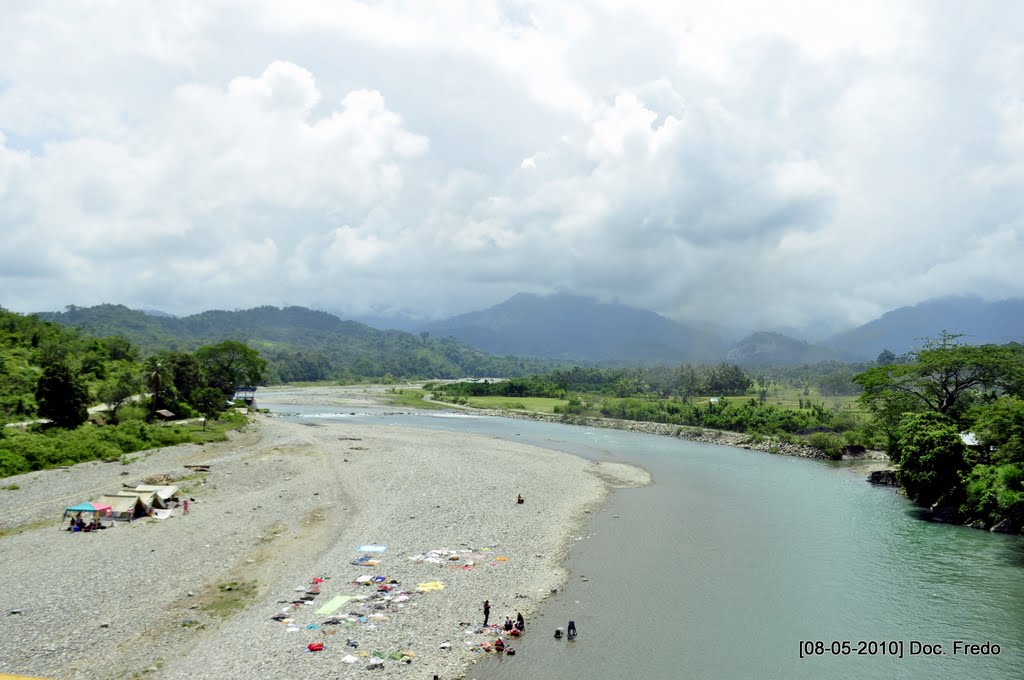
[0, 309, 266, 477]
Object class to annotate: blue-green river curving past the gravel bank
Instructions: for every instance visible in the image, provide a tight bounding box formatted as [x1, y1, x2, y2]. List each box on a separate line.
[261, 399, 1024, 680]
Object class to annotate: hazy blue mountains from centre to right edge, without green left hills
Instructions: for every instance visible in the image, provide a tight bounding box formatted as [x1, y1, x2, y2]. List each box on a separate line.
[422, 293, 1024, 365]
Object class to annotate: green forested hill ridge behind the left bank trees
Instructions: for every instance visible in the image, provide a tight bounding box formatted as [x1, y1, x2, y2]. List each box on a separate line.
[38, 304, 554, 382]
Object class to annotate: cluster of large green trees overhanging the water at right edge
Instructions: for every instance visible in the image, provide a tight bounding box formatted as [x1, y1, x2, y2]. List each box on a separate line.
[855, 335, 1024, 534]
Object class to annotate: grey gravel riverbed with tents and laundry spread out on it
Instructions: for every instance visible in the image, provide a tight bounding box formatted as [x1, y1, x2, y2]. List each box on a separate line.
[0, 403, 649, 679]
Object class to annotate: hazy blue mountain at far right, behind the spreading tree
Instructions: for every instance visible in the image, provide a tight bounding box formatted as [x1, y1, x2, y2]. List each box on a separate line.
[823, 297, 1024, 360]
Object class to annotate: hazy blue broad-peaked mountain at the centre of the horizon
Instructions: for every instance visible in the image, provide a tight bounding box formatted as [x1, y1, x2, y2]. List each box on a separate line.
[423, 293, 725, 364]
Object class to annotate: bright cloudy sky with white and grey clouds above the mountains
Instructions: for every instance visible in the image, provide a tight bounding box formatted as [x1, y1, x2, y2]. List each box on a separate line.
[0, 0, 1024, 329]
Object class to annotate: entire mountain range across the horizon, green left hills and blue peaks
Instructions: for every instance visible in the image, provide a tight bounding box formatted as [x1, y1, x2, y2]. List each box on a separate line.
[39, 293, 1024, 368]
